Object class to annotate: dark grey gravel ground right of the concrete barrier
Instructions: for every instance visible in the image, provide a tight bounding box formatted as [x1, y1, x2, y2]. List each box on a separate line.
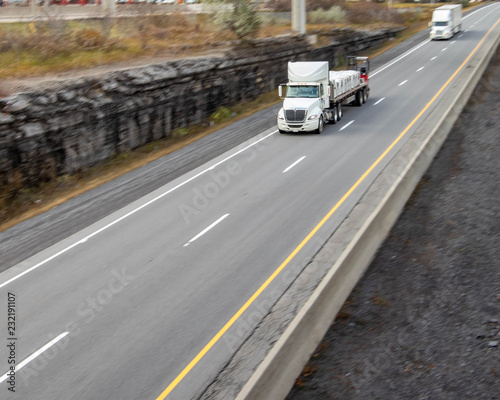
[287, 50, 500, 400]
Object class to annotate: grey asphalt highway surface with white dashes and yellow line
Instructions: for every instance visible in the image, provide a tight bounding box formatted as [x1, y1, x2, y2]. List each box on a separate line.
[0, 3, 500, 400]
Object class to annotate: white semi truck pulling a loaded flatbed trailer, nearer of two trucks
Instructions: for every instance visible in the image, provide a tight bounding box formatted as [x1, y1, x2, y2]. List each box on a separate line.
[278, 56, 370, 133]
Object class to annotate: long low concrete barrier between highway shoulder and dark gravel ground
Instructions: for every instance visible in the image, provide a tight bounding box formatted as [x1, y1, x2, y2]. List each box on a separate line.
[237, 26, 500, 400]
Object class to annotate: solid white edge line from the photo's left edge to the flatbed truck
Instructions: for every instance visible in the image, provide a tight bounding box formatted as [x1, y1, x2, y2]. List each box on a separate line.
[0, 130, 278, 289]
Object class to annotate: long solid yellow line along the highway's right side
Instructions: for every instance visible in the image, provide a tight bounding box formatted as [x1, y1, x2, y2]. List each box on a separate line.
[156, 19, 500, 400]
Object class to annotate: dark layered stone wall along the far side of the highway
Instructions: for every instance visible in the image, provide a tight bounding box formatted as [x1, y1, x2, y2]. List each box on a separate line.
[0, 30, 397, 194]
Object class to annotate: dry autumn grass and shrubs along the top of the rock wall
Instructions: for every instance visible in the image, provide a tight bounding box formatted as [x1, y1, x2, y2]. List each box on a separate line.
[0, 0, 470, 79]
